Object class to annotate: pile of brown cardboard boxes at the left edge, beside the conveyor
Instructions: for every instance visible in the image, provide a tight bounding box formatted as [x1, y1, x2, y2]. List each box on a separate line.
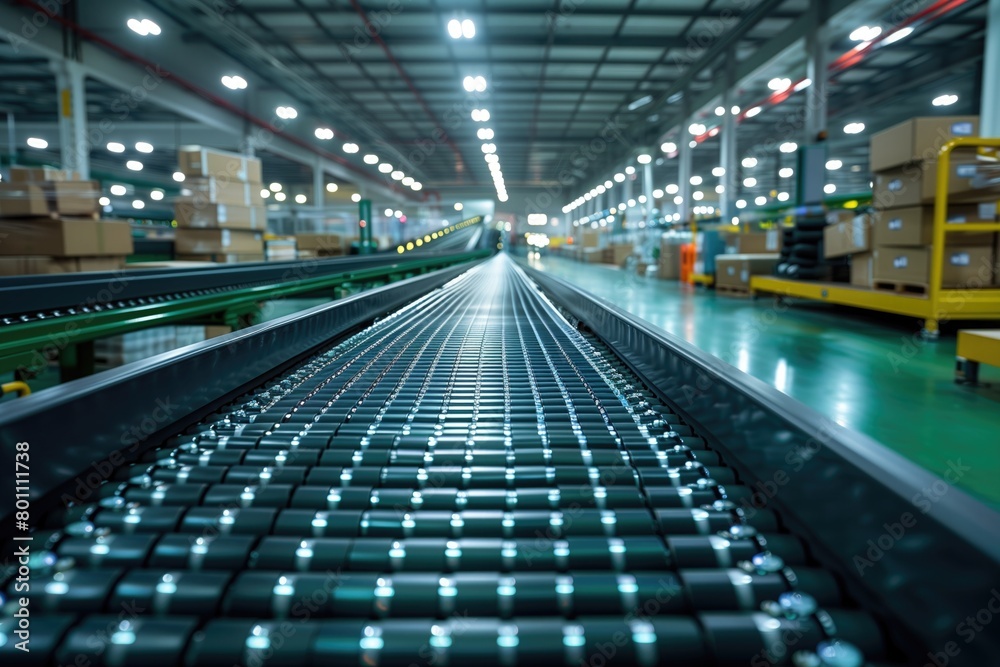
[0, 167, 132, 276]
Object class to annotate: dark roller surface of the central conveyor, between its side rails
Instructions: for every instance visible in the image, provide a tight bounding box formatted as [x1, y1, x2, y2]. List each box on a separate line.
[0, 257, 886, 667]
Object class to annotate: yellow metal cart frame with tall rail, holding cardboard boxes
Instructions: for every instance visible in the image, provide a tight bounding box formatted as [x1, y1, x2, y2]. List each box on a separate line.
[750, 138, 1000, 338]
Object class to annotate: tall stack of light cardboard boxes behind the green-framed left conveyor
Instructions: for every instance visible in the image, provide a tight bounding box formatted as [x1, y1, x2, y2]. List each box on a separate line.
[174, 146, 267, 264]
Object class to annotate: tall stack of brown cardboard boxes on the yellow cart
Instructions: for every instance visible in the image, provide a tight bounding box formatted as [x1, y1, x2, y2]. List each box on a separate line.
[864, 116, 1000, 294]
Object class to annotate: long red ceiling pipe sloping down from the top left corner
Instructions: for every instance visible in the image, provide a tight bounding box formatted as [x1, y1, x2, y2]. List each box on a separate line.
[15, 0, 428, 199]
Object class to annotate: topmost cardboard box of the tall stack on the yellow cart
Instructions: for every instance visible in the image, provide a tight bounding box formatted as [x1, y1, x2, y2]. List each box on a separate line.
[869, 116, 979, 172]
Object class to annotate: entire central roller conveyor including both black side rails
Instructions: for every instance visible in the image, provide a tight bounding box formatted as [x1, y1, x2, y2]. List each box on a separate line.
[0, 255, 1000, 667]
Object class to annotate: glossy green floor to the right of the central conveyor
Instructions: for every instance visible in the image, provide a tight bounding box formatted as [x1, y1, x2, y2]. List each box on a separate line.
[529, 256, 1000, 508]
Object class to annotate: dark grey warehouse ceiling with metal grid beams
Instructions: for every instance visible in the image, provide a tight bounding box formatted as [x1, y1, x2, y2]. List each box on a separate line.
[0, 0, 985, 210]
